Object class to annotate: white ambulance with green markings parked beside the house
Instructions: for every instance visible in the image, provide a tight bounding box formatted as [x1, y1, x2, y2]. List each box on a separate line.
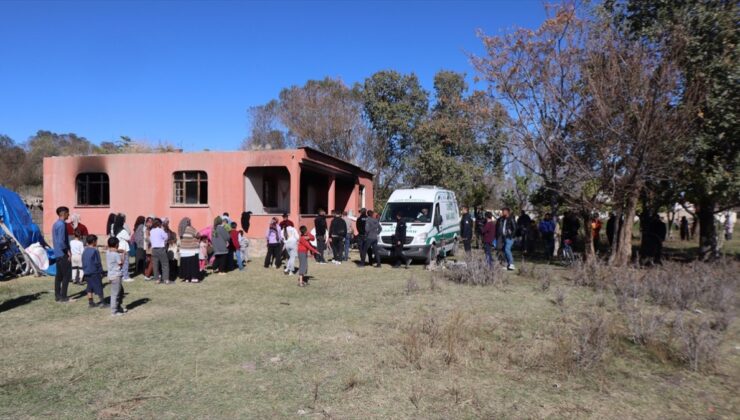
[378, 186, 460, 264]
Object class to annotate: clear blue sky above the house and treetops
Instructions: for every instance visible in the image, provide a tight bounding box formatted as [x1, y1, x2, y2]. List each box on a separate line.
[0, 0, 544, 150]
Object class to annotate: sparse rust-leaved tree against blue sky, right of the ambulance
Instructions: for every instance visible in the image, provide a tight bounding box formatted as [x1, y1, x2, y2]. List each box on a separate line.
[471, 4, 585, 218]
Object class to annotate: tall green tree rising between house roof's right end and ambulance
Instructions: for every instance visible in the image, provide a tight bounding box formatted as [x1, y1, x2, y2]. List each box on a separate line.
[362, 70, 429, 200]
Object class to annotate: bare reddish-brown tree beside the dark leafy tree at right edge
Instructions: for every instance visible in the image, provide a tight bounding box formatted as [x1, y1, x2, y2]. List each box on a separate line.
[578, 24, 695, 266]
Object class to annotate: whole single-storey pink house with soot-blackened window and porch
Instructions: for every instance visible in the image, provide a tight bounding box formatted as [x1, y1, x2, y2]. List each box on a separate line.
[43, 147, 373, 238]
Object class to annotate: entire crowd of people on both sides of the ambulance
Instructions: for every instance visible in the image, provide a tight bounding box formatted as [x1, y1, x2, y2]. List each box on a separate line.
[47, 203, 716, 315]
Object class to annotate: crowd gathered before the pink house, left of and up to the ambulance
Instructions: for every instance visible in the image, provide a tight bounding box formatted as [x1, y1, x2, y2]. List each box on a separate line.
[52, 207, 396, 316]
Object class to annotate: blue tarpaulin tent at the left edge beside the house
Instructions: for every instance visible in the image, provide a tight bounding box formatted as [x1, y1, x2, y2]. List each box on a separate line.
[0, 187, 44, 272]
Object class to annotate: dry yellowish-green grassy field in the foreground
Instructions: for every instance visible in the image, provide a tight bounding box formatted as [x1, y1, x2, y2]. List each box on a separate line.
[0, 249, 740, 419]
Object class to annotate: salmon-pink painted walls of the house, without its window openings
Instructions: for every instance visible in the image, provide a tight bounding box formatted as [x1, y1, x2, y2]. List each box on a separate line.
[44, 149, 373, 238]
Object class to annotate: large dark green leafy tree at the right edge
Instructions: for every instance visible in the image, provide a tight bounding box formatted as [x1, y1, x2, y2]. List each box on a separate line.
[605, 0, 740, 258]
